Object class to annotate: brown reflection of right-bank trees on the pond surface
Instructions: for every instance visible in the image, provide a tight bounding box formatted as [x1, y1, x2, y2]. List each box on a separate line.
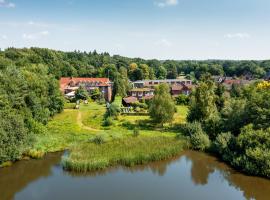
[184, 151, 270, 200]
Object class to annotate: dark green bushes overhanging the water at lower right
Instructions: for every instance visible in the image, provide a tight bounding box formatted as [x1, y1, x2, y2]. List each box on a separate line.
[213, 125, 270, 177]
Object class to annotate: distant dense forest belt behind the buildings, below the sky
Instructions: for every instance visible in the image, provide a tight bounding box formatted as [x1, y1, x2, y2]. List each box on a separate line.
[0, 48, 270, 80]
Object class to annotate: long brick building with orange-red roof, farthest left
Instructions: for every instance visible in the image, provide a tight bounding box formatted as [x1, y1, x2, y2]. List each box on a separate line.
[60, 77, 112, 101]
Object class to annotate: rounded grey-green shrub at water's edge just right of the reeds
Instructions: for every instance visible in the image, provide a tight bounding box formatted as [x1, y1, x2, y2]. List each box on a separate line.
[190, 132, 211, 151]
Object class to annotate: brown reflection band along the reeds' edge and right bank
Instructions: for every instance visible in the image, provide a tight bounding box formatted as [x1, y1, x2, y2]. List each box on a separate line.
[65, 151, 270, 200]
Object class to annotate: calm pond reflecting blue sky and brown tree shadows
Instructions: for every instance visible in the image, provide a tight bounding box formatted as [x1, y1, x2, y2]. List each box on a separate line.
[0, 151, 270, 200]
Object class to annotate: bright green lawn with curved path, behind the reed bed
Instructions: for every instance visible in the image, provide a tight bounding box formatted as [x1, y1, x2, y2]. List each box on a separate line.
[31, 103, 187, 154]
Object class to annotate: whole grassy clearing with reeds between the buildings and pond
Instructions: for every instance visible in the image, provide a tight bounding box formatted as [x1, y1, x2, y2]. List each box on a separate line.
[29, 100, 188, 171]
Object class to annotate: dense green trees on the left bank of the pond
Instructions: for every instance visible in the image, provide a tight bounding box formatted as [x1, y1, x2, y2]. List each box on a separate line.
[0, 63, 64, 165]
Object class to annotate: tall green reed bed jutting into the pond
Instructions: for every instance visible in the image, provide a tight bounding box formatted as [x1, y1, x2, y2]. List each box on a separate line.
[62, 137, 186, 172]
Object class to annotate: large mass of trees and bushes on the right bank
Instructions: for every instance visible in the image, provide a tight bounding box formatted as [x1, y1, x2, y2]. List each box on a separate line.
[185, 76, 270, 177]
